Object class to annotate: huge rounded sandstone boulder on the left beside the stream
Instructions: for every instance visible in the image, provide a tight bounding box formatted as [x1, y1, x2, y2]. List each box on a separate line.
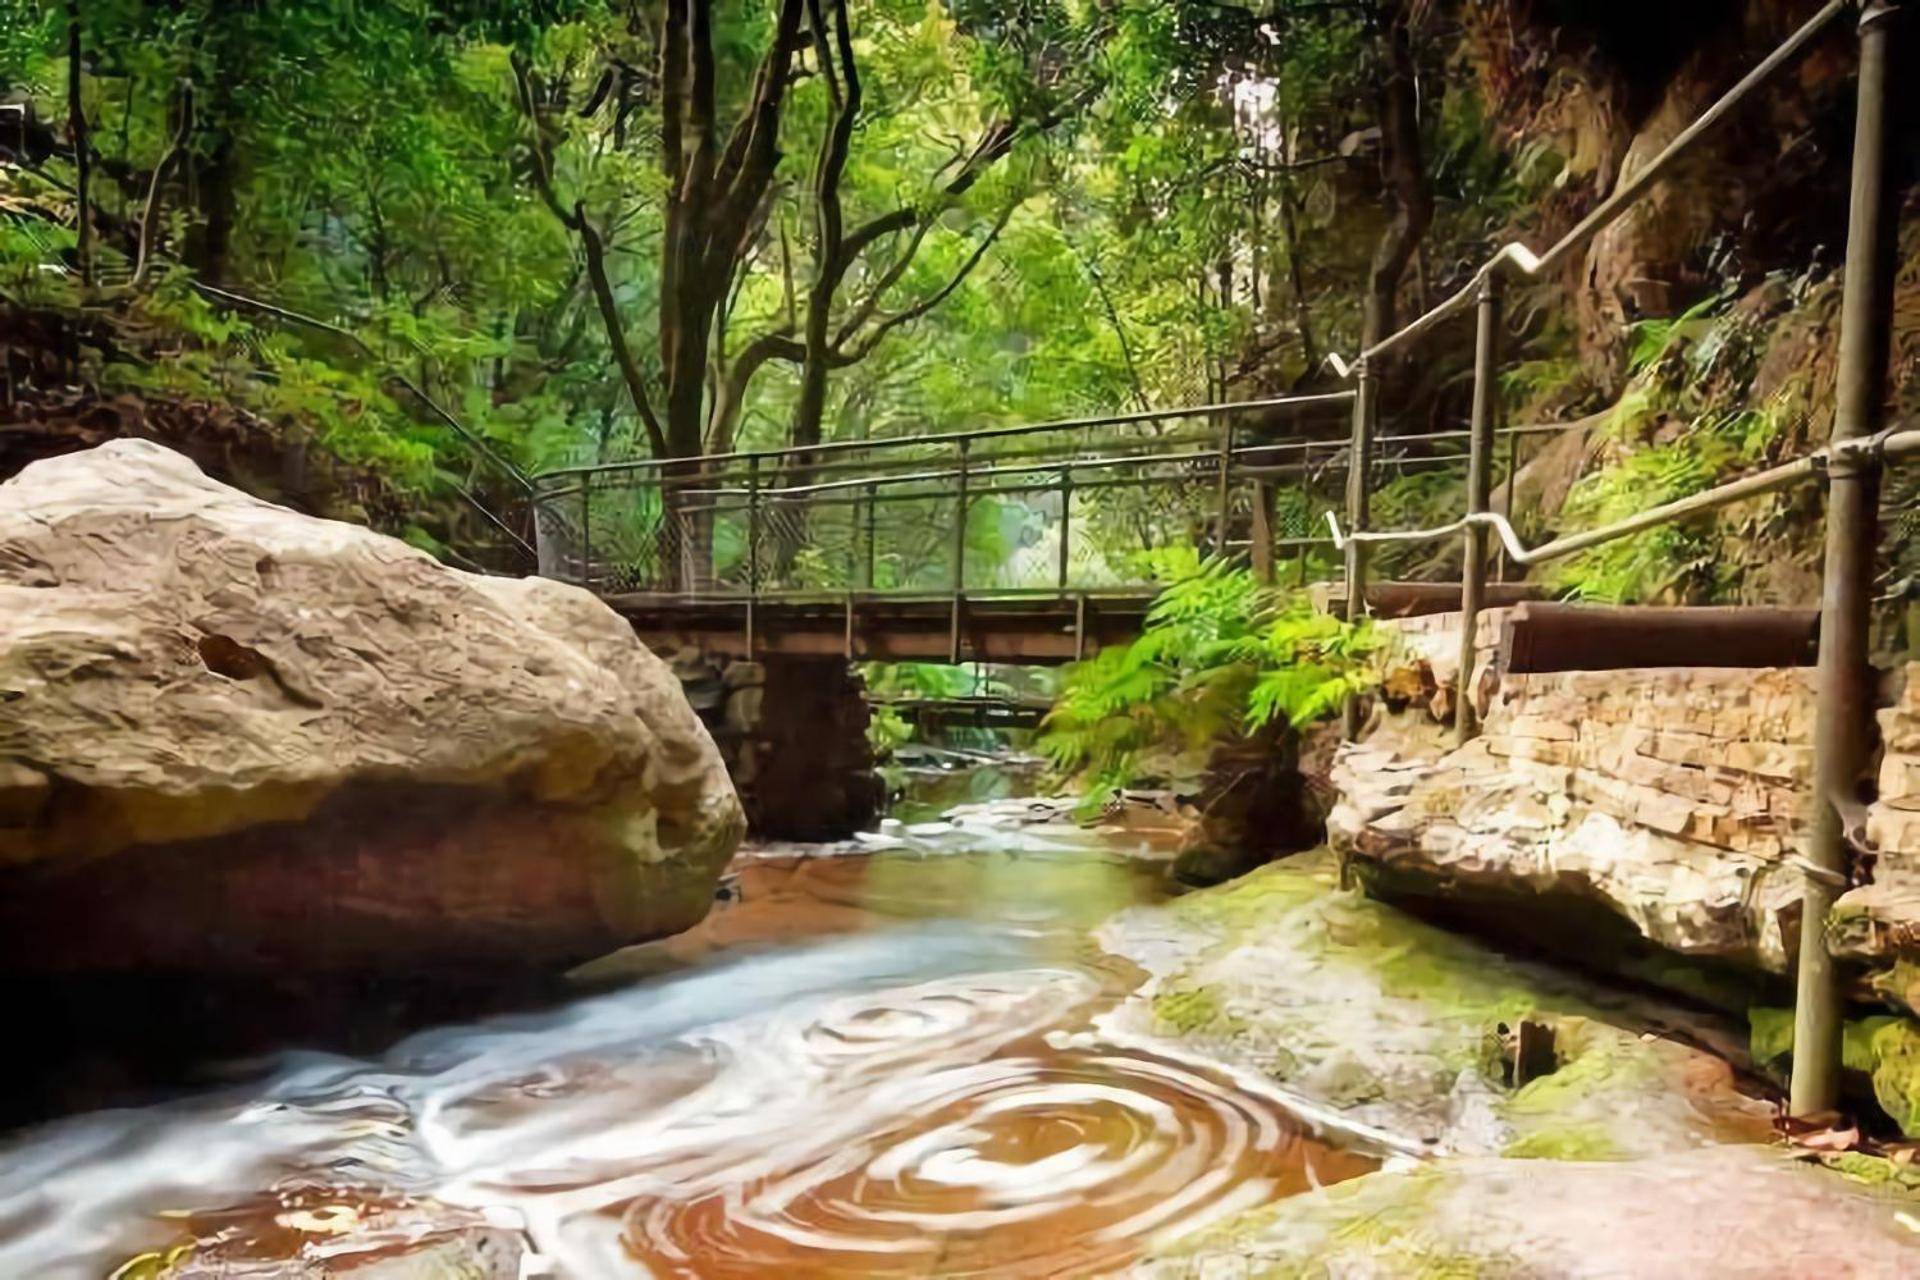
[0, 441, 743, 971]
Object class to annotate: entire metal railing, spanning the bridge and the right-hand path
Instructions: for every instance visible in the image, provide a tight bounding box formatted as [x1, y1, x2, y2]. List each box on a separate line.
[534, 0, 1920, 1115]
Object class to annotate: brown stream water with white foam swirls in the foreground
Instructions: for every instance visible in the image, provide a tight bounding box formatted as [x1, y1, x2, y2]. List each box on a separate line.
[0, 825, 1377, 1276]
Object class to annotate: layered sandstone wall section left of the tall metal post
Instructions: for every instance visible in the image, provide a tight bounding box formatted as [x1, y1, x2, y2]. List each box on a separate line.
[1329, 668, 1812, 971]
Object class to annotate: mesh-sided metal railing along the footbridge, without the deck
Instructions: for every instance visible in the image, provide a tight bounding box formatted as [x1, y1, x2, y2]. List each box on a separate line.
[534, 391, 1374, 603]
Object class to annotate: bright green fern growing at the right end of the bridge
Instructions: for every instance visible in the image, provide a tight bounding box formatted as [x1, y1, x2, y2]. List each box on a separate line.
[1037, 551, 1380, 804]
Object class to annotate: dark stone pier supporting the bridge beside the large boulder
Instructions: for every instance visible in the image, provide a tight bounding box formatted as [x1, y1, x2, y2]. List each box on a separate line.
[643, 652, 885, 841]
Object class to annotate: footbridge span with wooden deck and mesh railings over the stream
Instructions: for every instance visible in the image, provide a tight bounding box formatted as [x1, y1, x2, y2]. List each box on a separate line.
[534, 391, 1359, 662]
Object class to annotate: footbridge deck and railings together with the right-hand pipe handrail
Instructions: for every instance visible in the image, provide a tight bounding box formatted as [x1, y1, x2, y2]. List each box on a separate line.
[202, 0, 1920, 1115]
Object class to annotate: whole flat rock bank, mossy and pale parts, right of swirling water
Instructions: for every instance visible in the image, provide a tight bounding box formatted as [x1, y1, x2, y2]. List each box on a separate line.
[1102, 858, 1920, 1280]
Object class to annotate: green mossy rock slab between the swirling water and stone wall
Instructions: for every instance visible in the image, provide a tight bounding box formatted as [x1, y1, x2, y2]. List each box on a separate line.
[1102, 856, 1768, 1159]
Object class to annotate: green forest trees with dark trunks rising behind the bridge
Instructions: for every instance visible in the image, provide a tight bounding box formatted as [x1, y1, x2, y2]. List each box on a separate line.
[0, 0, 1528, 560]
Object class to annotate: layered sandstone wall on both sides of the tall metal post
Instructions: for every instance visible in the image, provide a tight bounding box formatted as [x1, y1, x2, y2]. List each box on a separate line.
[1329, 610, 1920, 1007]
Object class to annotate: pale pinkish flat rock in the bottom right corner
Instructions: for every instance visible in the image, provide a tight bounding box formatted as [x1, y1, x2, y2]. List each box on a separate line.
[1131, 1148, 1920, 1280]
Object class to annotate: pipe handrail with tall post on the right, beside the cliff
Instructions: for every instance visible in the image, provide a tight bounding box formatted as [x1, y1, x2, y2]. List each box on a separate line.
[1329, 0, 1920, 1115]
